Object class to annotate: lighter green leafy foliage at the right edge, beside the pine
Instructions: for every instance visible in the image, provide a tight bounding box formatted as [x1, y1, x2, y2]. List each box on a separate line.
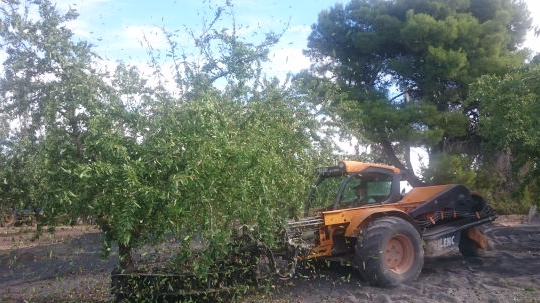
[470, 62, 540, 188]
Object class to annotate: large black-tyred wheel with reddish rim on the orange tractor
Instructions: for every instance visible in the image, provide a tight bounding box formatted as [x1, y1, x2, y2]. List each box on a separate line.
[355, 217, 424, 287]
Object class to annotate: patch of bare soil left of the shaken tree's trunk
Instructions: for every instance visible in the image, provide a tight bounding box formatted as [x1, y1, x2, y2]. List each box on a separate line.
[0, 226, 118, 303]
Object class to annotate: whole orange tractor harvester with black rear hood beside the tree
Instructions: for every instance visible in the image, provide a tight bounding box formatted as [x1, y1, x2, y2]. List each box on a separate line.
[286, 161, 496, 287]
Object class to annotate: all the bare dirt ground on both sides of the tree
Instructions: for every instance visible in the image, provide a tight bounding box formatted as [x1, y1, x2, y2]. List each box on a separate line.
[0, 216, 540, 303]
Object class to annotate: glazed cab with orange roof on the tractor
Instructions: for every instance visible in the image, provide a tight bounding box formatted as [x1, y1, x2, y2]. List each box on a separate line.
[304, 161, 401, 216]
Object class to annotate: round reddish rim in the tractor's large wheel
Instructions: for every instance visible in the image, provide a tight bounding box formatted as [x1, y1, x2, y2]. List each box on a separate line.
[384, 234, 414, 274]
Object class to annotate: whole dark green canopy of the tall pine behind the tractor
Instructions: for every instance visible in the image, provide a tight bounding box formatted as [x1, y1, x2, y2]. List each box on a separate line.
[306, 0, 530, 183]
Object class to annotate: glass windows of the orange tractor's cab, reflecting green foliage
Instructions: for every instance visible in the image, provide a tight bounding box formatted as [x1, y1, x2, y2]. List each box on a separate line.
[306, 173, 392, 216]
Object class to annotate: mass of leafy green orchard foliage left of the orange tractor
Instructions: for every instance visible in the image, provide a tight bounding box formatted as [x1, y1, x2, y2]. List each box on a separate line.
[0, 0, 332, 271]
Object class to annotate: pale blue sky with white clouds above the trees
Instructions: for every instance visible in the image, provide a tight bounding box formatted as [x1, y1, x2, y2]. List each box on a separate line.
[48, 0, 540, 78]
